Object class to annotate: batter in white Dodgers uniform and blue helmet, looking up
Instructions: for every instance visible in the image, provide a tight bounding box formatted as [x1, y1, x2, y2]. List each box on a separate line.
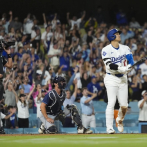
[101, 29, 134, 134]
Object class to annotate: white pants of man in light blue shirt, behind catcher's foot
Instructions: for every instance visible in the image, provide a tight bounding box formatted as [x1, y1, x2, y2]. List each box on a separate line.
[82, 114, 96, 128]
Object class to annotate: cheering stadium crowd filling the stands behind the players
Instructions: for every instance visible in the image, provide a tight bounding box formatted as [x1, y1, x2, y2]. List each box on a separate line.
[0, 8, 147, 128]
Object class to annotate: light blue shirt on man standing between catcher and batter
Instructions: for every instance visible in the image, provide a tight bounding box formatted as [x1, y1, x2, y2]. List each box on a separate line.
[80, 96, 93, 115]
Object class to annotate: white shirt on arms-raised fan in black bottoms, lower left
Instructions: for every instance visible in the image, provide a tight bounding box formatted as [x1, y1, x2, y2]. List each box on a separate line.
[17, 100, 29, 118]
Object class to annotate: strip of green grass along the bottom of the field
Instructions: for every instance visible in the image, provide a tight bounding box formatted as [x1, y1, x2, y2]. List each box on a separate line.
[0, 134, 147, 147]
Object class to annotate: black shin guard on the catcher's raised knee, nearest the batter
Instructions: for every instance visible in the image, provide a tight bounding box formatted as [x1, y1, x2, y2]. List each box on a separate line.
[66, 104, 82, 128]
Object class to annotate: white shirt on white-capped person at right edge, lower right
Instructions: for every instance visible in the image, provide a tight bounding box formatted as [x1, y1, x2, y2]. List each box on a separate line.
[138, 99, 147, 121]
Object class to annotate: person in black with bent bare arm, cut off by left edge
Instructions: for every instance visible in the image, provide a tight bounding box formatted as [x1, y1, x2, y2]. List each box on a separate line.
[0, 43, 12, 134]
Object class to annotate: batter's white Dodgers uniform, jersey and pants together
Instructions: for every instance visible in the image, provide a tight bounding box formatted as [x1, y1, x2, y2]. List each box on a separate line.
[102, 44, 132, 129]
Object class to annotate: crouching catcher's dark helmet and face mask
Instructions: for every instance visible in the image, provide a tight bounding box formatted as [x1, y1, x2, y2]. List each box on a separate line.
[53, 76, 66, 89]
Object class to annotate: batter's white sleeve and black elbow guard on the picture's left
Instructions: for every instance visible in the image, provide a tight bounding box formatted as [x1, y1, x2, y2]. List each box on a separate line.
[102, 48, 118, 70]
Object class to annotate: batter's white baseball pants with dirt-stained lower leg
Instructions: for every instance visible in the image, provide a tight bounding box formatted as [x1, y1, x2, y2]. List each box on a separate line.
[104, 74, 128, 129]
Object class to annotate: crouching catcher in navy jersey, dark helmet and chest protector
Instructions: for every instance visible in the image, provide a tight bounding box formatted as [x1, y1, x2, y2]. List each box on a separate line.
[39, 76, 93, 134]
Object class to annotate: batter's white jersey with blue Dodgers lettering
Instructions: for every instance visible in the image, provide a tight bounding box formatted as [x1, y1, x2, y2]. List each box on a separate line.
[101, 44, 134, 74]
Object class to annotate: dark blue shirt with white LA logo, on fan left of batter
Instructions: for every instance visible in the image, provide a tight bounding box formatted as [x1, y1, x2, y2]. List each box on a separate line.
[87, 82, 102, 100]
